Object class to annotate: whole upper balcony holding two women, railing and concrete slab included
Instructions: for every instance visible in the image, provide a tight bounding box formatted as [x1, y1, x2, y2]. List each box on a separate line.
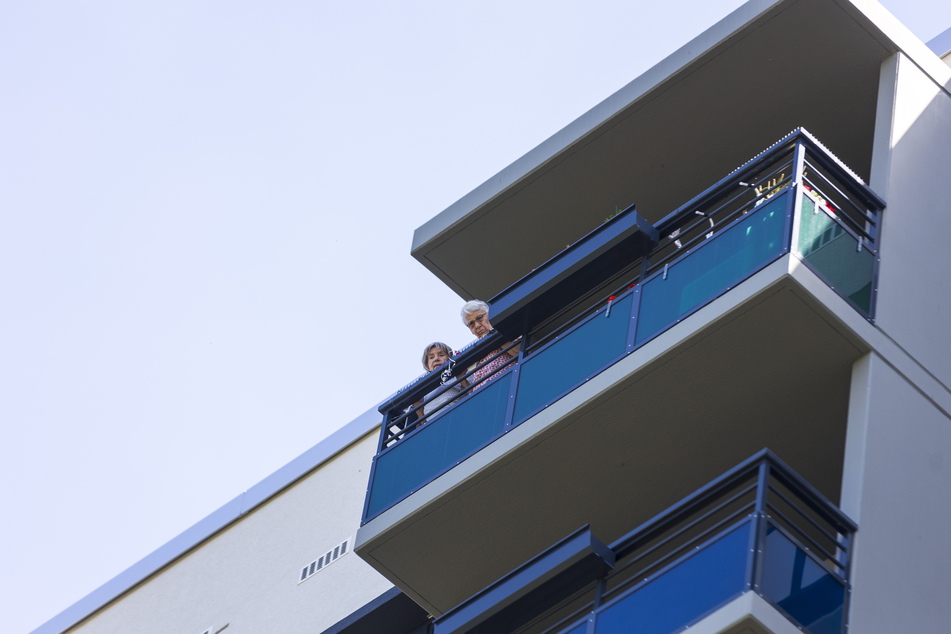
[356, 130, 884, 615]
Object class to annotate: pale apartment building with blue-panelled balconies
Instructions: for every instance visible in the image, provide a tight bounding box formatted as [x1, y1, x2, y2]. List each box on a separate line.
[37, 0, 951, 634]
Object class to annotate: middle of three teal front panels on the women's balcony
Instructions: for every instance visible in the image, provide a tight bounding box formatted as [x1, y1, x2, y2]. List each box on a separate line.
[513, 295, 633, 423]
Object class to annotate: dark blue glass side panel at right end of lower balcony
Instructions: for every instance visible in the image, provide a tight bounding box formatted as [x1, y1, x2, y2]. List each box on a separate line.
[760, 527, 845, 634]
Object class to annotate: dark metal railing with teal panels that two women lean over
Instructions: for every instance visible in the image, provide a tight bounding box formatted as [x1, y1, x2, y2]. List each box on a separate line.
[363, 129, 884, 523]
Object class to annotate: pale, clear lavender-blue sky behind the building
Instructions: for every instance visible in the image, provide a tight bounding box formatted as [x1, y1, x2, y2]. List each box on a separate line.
[0, 0, 951, 632]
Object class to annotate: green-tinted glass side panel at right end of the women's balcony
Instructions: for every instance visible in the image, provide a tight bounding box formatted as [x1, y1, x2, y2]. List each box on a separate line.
[798, 194, 875, 317]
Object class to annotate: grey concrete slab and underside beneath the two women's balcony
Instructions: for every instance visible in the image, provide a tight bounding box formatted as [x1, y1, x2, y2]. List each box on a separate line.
[357, 262, 867, 615]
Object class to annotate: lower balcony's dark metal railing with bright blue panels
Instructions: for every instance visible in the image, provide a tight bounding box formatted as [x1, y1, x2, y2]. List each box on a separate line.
[435, 450, 856, 634]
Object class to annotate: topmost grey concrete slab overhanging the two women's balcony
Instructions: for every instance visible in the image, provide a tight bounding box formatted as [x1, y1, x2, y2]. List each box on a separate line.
[413, 0, 897, 299]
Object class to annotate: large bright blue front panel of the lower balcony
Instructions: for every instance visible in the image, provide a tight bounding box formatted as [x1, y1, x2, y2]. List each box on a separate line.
[595, 522, 750, 634]
